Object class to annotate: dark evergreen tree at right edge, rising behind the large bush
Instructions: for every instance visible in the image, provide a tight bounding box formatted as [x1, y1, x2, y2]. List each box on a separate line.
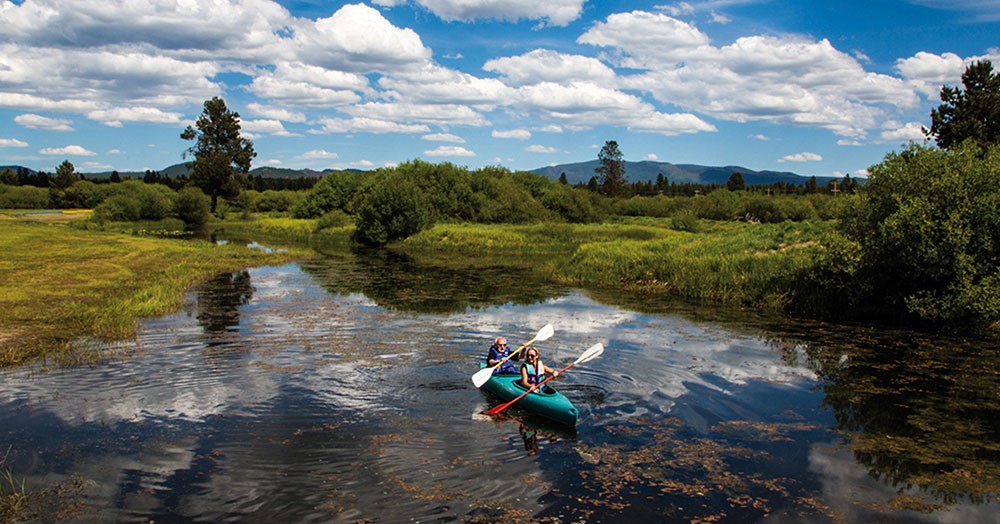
[924, 60, 1000, 149]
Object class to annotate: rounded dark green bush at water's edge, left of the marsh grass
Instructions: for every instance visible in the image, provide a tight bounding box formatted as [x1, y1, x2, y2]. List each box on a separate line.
[354, 170, 432, 246]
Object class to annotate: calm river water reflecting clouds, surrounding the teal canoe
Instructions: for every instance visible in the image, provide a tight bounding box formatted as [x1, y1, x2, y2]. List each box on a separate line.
[0, 247, 1000, 523]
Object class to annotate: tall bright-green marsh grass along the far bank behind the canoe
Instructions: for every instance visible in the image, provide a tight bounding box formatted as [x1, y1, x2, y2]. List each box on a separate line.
[400, 217, 835, 309]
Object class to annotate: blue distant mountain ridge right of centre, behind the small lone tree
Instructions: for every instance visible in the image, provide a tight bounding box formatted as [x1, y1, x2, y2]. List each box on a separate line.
[532, 160, 837, 185]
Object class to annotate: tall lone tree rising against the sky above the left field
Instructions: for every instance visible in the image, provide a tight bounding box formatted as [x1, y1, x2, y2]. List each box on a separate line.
[181, 97, 257, 212]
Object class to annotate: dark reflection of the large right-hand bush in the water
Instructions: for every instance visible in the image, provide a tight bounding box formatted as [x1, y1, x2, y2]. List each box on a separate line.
[807, 333, 1000, 509]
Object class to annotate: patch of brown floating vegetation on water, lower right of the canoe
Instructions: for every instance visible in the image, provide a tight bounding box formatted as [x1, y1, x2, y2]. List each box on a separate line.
[579, 417, 834, 522]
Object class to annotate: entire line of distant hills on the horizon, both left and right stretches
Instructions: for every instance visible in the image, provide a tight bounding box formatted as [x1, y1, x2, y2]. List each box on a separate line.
[0, 160, 837, 186]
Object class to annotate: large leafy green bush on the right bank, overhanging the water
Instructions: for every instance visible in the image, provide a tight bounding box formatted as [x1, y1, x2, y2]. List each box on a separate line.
[845, 140, 1000, 328]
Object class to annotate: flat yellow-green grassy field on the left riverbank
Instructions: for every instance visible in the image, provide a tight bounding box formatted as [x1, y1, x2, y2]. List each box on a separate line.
[0, 212, 306, 366]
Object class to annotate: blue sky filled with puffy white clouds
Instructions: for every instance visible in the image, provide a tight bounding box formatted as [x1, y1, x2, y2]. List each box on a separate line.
[0, 0, 1000, 176]
